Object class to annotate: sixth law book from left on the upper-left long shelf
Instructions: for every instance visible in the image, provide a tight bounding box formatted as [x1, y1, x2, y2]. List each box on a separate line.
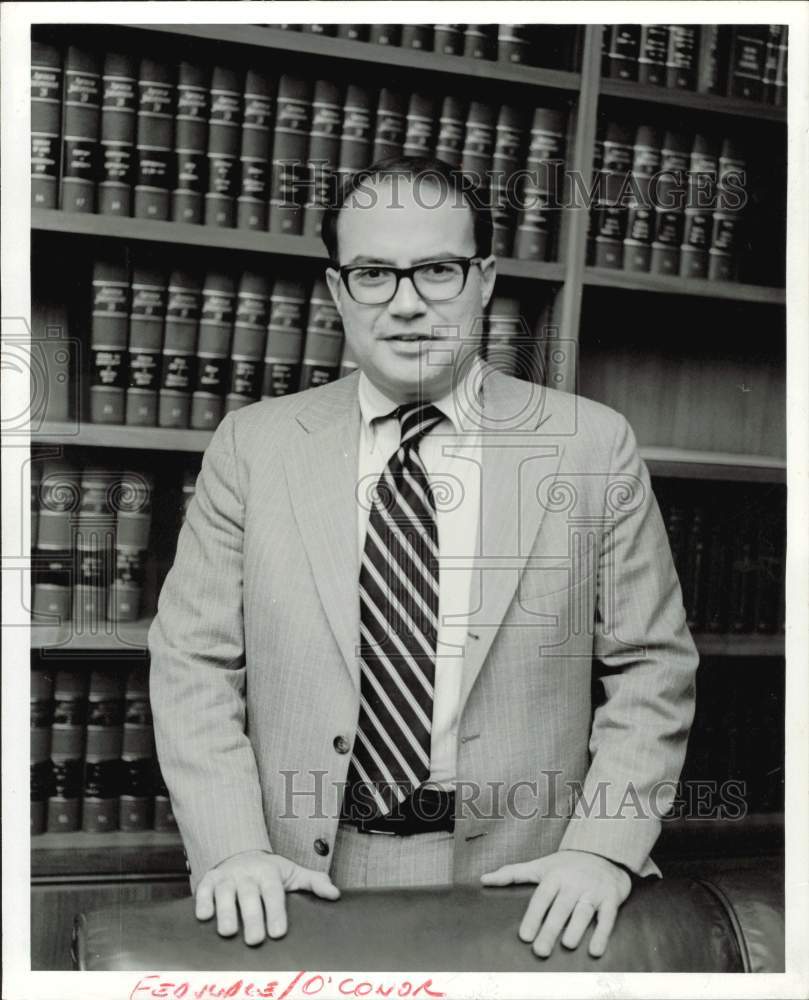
[205, 66, 243, 229]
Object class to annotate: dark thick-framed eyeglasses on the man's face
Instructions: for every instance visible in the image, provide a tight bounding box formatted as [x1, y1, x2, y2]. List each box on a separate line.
[339, 257, 483, 306]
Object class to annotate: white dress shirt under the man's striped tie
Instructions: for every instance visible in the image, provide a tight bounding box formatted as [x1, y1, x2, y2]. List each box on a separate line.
[357, 359, 481, 790]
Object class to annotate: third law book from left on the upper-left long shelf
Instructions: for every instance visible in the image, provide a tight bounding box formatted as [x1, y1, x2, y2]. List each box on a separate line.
[98, 52, 138, 217]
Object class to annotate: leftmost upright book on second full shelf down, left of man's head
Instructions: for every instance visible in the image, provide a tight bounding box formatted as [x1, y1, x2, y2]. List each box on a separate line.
[90, 258, 129, 424]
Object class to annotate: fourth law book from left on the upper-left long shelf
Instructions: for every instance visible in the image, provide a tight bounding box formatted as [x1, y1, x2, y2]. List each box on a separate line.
[133, 56, 175, 219]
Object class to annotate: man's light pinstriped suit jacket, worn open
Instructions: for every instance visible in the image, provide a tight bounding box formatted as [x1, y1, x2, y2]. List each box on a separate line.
[149, 369, 698, 888]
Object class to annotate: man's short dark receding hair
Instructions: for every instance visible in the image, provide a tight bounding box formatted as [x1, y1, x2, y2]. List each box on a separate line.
[320, 156, 492, 263]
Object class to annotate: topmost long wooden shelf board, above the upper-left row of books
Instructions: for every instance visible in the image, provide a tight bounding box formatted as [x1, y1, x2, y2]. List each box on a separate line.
[128, 24, 581, 93]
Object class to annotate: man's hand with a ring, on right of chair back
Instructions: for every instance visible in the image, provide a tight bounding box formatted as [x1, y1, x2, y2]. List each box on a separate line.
[481, 851, 632, 958]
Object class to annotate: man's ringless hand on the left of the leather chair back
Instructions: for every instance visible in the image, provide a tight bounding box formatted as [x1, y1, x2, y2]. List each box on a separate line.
[195, 851, 340, 945]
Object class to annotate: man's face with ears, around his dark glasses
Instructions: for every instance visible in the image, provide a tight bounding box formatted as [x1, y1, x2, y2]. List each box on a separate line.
[326, 176, 495, 402]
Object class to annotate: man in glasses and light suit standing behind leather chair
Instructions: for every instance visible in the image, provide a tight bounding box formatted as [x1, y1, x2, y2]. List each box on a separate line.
[150, 160, 697, 956]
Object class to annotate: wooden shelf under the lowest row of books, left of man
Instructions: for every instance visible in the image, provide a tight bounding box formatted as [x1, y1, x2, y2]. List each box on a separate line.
[31, 830, 187, 879]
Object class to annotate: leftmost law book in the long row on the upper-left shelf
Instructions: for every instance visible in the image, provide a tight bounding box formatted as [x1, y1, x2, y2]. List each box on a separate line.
[31, 41, 62, 208]
